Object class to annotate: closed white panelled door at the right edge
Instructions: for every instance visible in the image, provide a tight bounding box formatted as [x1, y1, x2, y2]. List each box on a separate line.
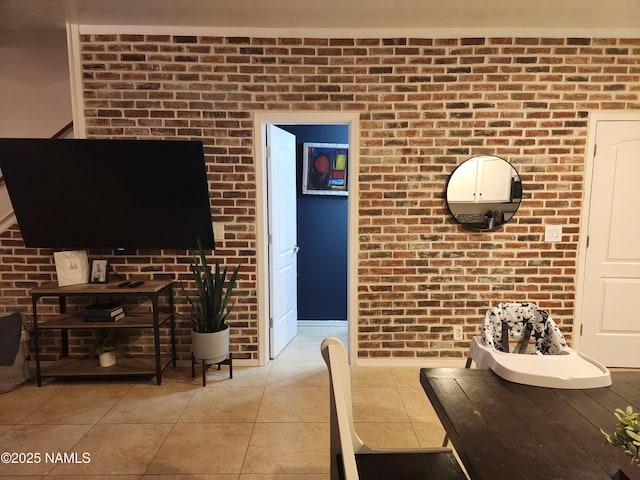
[578, 120, 640, 367]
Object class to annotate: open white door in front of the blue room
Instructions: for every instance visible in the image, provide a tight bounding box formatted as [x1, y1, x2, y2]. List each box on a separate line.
[267, 124, 298, 358]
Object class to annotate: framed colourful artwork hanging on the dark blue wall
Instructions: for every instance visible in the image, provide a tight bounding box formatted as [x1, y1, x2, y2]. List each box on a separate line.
[302, 143, 349, 196]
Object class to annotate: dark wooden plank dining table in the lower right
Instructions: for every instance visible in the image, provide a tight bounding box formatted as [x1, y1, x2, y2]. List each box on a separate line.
[420, 368, 640, 480]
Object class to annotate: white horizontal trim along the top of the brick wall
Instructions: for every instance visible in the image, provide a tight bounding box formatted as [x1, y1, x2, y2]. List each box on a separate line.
[78, 25, 640, 38]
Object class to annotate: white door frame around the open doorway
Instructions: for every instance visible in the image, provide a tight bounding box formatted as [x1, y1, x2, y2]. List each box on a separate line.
[253, 111, 360, 366]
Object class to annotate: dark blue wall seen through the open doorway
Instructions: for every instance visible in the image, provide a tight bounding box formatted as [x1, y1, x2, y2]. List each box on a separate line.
[278, 125, 344, 320]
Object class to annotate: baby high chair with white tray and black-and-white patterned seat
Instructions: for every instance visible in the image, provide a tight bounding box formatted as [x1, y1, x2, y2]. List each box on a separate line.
[467, 303, 611, 389]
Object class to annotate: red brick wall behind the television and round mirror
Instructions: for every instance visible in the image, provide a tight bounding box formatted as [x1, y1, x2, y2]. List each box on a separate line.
[2, 34, 640, 358]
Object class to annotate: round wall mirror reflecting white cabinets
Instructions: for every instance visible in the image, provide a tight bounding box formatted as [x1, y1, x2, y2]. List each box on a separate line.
[447, 155, 522, 231]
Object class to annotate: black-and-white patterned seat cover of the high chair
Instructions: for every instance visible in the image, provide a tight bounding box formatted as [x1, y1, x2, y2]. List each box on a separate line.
[480, 303, 570, 355]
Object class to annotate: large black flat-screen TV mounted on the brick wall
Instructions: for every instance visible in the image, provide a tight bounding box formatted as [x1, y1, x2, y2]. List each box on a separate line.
[0, 139, 214, 250]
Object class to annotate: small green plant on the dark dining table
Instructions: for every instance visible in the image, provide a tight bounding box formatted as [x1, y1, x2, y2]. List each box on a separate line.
[600, 407, 640, 480]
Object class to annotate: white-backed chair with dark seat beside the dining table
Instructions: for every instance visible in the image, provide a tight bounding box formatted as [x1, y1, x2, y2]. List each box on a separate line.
[321, 337, 467, 480]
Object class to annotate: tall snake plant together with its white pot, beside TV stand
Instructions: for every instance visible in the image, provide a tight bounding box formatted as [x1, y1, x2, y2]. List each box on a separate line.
[181, 240, 240, 364]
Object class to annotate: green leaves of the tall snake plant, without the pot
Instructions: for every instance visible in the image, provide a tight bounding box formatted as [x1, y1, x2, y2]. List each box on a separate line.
[180, 240, 240, 333]
